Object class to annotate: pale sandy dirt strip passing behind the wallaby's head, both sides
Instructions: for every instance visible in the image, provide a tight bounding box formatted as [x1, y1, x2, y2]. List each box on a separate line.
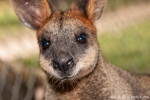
[0, 4, 150, 62]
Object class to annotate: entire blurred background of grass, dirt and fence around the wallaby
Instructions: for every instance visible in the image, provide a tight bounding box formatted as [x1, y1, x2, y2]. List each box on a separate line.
[0, 0, 150, 100]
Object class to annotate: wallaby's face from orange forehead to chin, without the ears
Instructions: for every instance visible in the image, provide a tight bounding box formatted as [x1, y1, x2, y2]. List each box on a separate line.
[38, 12, 98, 79]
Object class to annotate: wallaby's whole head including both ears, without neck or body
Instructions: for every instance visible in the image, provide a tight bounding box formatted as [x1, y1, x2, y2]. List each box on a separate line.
[10, 0, 106, 80]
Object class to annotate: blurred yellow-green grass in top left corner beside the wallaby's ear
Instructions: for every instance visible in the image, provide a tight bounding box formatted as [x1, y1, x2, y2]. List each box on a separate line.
[0, 0, 24, 40]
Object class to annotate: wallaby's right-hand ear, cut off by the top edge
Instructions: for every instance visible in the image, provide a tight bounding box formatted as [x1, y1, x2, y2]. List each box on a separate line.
[71, 0, 107, 22]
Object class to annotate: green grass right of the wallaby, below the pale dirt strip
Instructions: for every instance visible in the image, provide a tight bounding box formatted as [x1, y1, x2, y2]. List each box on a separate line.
[98, 20, 150, 73]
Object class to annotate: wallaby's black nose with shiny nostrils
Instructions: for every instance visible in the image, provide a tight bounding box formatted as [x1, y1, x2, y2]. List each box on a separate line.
[53, 54, 74, 73]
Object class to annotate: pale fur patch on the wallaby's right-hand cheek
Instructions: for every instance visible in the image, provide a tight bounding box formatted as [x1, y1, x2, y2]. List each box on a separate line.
[72, 47, 98, 77]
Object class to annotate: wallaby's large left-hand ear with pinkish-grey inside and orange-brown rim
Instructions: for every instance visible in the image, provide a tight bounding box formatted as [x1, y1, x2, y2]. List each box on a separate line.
[10, 0, 52, 30]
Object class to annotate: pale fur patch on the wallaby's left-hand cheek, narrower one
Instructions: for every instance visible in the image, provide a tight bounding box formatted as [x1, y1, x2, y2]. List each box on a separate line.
[40, 55, 60, 78]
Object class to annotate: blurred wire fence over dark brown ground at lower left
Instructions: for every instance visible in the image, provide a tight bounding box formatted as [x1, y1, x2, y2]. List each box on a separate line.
[0, 62, 46, 100]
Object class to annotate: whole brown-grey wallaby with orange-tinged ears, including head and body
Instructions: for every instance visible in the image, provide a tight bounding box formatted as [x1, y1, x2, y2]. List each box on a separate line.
[10, 0, 150, 100]
